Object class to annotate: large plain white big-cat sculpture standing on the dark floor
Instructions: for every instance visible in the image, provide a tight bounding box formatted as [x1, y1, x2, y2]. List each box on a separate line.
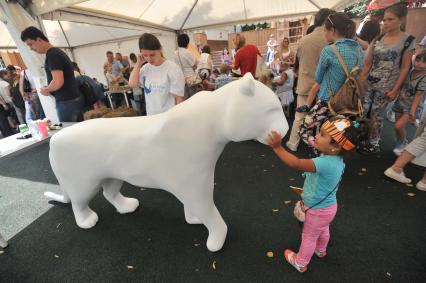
[45, 73, 288, 251]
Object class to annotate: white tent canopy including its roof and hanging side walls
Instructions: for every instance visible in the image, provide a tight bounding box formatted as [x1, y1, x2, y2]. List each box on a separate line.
[0, 0, 354, 85]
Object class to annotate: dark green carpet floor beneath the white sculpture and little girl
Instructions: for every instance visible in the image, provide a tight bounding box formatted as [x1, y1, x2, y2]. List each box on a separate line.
[0, 122, 426, 282]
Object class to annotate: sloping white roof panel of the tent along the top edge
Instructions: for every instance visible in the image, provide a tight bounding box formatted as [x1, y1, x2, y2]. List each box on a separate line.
[32, 0, 353, 30]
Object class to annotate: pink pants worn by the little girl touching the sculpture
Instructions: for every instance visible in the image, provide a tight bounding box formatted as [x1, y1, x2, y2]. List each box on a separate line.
[296, 203, 337, 266]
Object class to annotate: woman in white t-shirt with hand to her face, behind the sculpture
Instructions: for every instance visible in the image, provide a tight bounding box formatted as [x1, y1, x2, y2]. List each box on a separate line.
[129, 33, 185, 115]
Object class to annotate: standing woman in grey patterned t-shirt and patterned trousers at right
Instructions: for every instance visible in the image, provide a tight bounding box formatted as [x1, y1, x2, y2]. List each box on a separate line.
[361, 3, 415, 154]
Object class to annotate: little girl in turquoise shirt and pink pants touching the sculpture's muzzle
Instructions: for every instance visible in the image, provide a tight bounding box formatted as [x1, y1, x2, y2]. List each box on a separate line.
[268, 118, 368, 272]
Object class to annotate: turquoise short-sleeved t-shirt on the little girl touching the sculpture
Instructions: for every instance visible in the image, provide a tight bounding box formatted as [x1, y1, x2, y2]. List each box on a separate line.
[302, 155, 345, 209]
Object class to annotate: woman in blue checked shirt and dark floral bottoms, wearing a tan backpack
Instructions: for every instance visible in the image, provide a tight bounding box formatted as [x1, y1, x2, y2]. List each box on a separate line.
[296, 13, 363, 149]
